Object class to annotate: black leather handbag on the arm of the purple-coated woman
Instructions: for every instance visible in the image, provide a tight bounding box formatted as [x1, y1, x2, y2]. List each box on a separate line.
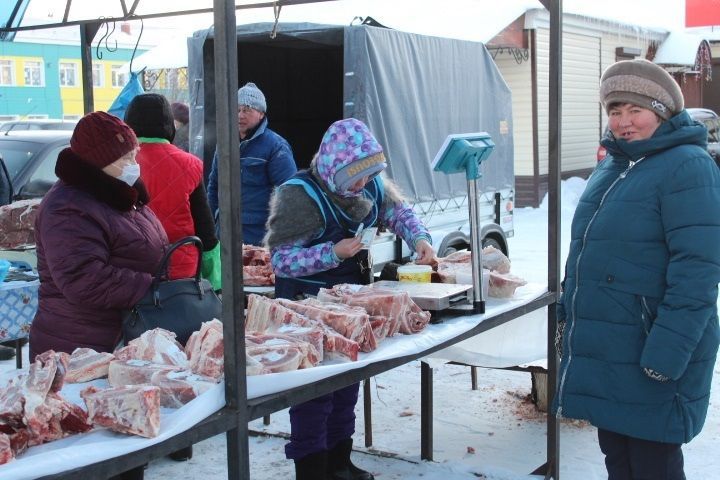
[122, 237, 222, 345]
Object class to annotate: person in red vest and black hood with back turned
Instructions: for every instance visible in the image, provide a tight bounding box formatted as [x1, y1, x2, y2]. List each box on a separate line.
[125, 93, 220, 289]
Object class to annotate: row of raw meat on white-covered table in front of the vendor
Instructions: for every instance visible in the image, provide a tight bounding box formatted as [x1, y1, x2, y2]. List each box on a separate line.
[245, 285, 430, 375]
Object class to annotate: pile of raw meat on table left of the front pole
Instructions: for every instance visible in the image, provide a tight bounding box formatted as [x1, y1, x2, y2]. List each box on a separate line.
[0, 320, 223, 464]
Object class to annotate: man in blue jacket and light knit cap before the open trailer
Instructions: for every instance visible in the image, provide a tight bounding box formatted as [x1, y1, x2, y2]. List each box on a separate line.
[208, 82, 297, 246]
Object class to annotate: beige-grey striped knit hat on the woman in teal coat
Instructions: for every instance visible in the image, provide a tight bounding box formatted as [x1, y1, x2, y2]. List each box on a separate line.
[600, 59, 685, 120]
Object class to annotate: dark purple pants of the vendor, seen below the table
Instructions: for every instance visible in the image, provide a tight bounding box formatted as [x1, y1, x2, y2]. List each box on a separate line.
[285, 383, 360, 460]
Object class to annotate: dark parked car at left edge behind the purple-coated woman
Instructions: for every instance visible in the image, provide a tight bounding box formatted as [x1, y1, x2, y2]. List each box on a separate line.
[0, 130, 72, 205]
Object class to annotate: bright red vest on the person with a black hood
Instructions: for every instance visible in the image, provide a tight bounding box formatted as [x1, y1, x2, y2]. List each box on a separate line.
[136, 138, 203, 278]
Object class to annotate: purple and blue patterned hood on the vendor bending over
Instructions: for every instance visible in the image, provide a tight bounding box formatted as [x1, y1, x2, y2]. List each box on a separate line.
[317, 118, 387, 195]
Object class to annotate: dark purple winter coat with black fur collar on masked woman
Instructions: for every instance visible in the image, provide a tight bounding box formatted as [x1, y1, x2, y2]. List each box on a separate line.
[30, 148, 167, 358]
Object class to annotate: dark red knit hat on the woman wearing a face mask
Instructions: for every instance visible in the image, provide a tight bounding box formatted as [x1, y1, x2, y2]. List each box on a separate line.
[70, 112, 138, 169]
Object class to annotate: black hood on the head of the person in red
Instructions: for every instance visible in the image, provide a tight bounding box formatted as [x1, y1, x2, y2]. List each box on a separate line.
[125, 93, 175, 142]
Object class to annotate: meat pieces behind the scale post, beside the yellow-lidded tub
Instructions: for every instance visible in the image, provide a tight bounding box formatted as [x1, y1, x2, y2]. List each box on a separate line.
[437, 246, 527, 298]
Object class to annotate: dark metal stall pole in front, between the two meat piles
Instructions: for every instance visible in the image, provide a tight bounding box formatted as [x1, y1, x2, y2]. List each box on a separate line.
[213, 0, 250, 480]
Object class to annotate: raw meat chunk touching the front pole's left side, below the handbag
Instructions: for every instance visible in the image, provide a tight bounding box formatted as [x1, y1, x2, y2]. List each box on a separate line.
[185, 319, 225, 380]
